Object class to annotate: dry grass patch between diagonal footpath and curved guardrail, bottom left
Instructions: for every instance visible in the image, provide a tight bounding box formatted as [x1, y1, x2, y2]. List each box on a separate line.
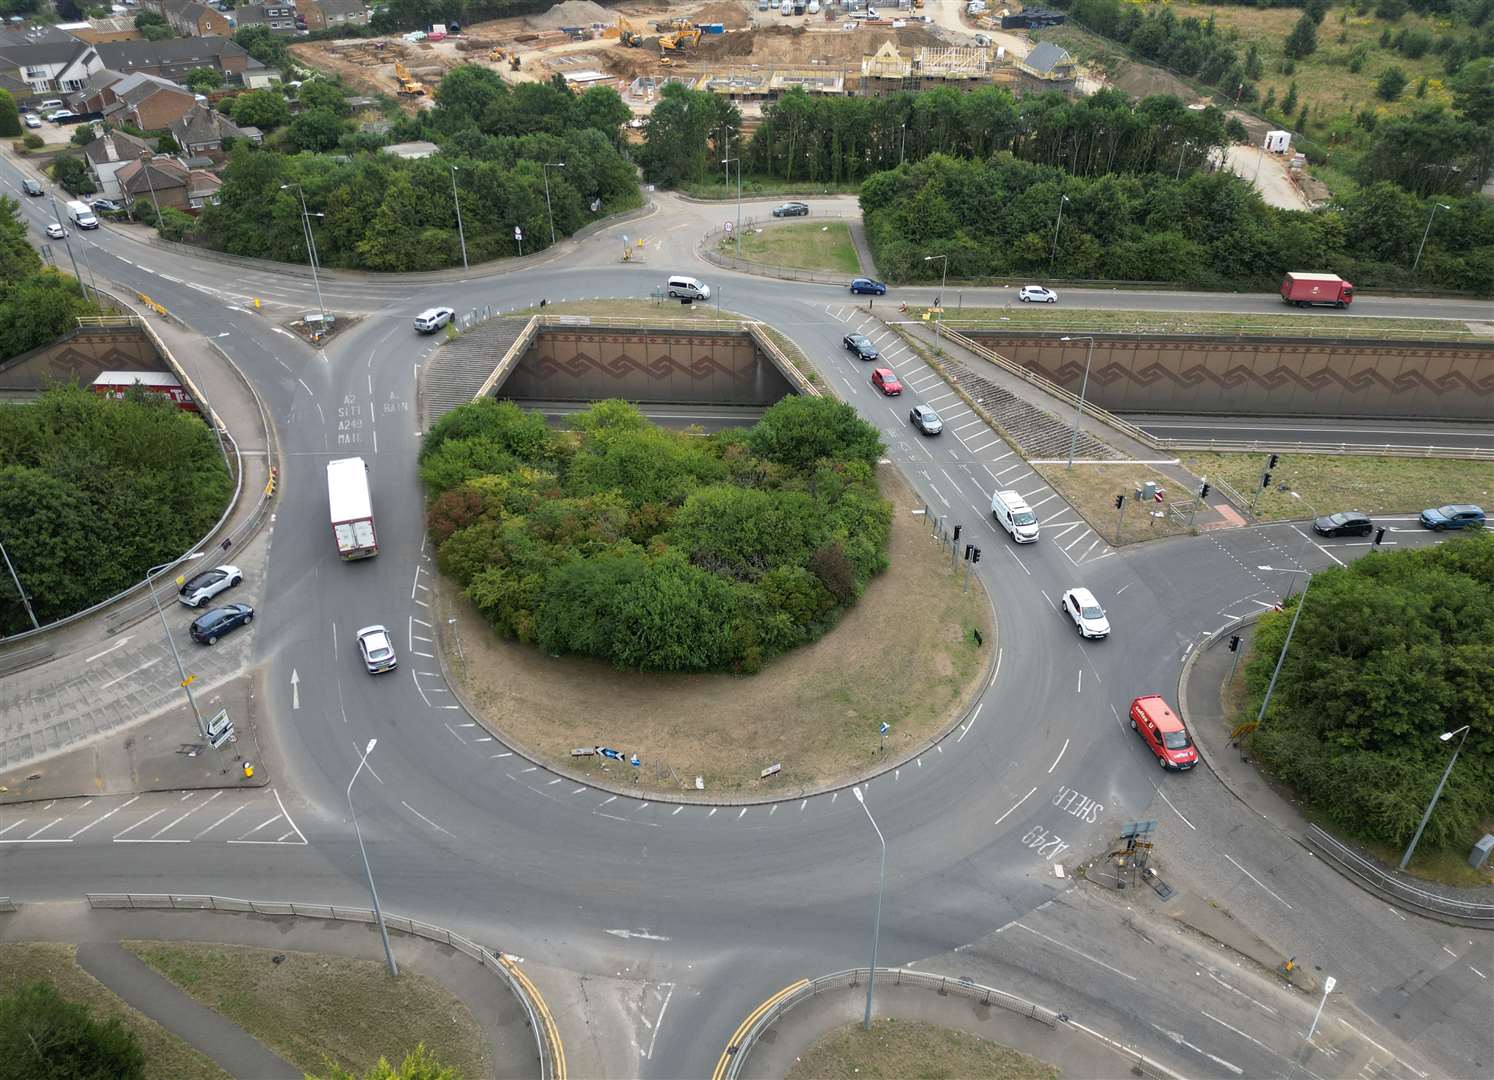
[123, 941, 492, 1077]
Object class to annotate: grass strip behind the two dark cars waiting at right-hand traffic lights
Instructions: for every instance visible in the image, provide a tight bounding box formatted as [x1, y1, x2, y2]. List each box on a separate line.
[1182, 451, 1494, 527]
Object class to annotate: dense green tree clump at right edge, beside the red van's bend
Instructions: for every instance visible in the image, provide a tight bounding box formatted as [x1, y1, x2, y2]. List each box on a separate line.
[1246, 533, 1494, 847]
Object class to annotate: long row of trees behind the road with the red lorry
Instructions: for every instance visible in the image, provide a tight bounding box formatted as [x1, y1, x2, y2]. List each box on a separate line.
[861, 154, 1494, 294]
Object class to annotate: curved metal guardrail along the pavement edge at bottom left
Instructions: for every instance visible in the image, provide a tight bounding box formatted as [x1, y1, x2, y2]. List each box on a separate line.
[84, 893, 566, 1080]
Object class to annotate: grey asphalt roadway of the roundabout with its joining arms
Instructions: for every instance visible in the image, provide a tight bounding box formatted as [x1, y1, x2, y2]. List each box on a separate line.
[0, 177, 1494, 1077]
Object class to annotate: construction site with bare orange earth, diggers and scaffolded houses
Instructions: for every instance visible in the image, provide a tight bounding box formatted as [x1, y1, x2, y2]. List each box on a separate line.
[291, 0, 1076, 128]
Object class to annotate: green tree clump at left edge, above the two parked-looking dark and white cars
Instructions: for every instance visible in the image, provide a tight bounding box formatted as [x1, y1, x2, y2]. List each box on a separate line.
[0, 385, 233, 635]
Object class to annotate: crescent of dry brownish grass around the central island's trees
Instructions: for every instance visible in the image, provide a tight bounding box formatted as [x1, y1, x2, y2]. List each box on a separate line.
[438, 468, 995, 798]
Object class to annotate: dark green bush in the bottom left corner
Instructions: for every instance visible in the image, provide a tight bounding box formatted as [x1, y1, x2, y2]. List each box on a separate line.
[0, 981, 144, 1080]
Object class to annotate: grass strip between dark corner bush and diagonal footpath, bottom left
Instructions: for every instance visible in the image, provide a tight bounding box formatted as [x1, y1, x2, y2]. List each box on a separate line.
[0, 943, 229, 1080]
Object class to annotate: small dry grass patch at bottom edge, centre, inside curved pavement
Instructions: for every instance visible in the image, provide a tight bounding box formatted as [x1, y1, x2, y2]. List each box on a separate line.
[784, 1019, 1059, 1080]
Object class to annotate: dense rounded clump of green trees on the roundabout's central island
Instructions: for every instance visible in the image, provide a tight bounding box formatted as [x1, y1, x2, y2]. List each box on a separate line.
[421, 397, 892, 672]
